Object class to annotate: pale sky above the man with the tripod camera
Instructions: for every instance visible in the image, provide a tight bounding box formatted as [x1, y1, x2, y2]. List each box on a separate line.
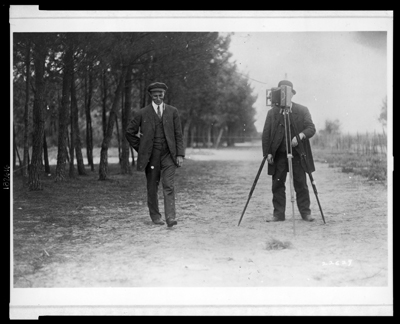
[225, 31, 387, 133]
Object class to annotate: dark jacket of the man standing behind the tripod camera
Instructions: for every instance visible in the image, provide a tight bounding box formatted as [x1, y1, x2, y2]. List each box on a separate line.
[262, 102, 315, 175]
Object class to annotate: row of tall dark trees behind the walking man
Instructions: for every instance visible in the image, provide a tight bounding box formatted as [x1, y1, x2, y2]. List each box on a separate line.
[13, 32, 256, 190]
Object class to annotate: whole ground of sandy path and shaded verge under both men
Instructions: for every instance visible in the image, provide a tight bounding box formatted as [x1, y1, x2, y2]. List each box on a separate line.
[13, 146, 388, 287]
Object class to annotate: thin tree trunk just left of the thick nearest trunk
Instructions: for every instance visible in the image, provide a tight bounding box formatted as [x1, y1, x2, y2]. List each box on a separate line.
[21, 42, 31, 177]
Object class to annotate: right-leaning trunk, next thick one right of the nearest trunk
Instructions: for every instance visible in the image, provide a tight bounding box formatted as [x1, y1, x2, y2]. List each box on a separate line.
[55, 47, 73, 181]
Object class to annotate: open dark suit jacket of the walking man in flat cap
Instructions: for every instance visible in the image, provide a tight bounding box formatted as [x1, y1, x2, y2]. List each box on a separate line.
[125, 104, 185, 171]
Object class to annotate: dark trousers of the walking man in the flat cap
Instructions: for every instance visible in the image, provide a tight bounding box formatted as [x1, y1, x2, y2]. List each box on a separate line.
[145, 142, 176, 221]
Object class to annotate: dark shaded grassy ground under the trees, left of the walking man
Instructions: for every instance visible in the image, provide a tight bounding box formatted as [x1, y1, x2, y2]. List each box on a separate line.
[13, 164, 145, 286]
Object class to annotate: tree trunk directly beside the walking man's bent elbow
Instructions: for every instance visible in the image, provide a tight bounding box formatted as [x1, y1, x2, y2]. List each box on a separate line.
[121, 67, 135, 174]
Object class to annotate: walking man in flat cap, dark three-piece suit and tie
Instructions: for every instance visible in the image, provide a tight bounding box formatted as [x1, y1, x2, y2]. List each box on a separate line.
[126, 82, 185, 227]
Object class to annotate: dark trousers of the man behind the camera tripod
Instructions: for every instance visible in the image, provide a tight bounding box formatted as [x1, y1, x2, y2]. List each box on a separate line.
[272, 152, 311, 219]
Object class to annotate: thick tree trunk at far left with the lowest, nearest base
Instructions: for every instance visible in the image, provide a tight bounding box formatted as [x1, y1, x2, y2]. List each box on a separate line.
[29, 35, 46, 190]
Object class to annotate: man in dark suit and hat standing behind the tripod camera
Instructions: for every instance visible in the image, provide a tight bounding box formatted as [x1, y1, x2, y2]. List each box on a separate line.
[262, 80, 315, 222]
